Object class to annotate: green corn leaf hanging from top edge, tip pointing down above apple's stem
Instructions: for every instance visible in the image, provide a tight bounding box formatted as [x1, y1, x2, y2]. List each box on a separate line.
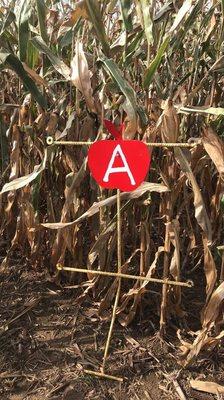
[85, 0, 110, 56]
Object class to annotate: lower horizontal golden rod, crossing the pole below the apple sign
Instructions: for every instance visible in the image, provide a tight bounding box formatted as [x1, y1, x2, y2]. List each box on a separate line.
[57, 264, 193, 287]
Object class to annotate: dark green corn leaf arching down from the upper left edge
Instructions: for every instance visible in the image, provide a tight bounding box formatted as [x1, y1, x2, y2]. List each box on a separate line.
[0, 51, 47, 109]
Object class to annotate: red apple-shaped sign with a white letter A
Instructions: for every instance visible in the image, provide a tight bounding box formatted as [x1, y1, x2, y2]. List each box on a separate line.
[88, 120, 150, 192]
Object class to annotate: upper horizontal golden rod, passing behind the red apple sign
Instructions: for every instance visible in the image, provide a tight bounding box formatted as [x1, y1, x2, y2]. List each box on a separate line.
[47, 136, 197, 147]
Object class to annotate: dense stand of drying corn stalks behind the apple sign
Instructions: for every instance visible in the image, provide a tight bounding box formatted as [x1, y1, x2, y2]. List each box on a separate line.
[0, 0, 224, 398]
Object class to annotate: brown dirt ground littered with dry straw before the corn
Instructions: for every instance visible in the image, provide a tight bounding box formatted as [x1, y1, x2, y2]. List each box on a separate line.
[0, 248, 224, 400]
